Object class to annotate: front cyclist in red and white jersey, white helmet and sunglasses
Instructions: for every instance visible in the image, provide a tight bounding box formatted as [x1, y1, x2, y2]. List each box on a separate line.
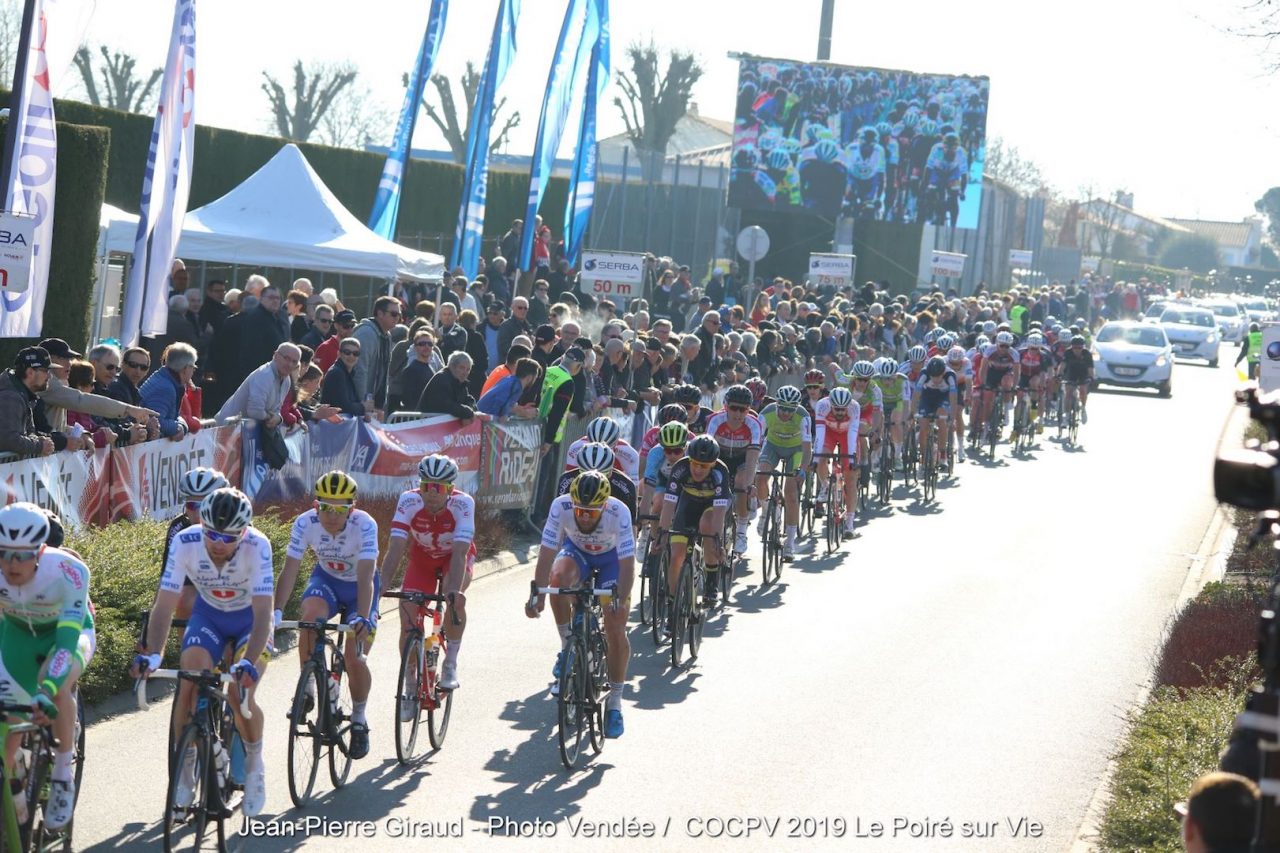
[381, 453, 476, 691]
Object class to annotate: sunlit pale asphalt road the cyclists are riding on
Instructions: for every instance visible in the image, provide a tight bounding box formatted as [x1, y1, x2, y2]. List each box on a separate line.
[76, 350, 1234, 852]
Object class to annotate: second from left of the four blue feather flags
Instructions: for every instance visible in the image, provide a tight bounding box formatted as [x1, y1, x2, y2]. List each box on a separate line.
[449, 0, 520, 277]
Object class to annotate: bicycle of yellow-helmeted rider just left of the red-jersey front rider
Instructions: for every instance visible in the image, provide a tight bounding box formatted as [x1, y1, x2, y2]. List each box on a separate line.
[279, 620, 356, 808]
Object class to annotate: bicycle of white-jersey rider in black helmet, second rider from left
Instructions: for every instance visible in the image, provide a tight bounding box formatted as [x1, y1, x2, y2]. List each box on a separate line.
[134, 670, 252, 853]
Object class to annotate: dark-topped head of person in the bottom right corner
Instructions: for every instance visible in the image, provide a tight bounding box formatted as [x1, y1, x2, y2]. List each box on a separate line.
[1174, 772, 1261, 853]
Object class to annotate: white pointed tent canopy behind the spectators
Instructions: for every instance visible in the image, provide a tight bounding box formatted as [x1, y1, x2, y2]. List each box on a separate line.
[101, 143, 444, 280]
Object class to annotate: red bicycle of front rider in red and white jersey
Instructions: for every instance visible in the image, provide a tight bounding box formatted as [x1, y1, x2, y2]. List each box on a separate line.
[383, 589, 460, 765]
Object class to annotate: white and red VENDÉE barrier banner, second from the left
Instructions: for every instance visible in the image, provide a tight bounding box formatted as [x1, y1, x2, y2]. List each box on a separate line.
[112, 424, 241, 521]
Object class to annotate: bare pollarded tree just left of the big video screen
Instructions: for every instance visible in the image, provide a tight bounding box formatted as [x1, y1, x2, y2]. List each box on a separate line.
[613, 41, 703, 177]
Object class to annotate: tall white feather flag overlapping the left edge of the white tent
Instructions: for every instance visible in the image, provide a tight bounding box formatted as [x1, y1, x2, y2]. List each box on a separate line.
[120, 0, 196, 346]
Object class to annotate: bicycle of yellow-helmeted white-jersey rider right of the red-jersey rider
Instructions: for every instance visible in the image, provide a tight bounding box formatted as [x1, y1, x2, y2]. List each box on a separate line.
[530, 576, 618, 770]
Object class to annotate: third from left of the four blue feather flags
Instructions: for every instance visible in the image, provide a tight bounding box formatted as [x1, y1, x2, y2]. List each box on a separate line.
[517, 0, 599, 270]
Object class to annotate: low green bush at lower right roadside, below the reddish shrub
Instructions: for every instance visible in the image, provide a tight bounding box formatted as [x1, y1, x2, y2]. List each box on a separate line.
[1101, 658, 1253, 853]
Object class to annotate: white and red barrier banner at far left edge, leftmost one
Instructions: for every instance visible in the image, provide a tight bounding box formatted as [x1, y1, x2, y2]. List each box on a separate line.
[0, 448, 111, 528]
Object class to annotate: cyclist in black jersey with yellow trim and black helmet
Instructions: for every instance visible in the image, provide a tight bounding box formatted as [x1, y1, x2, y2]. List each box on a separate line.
[658, 435, 732, 607]
